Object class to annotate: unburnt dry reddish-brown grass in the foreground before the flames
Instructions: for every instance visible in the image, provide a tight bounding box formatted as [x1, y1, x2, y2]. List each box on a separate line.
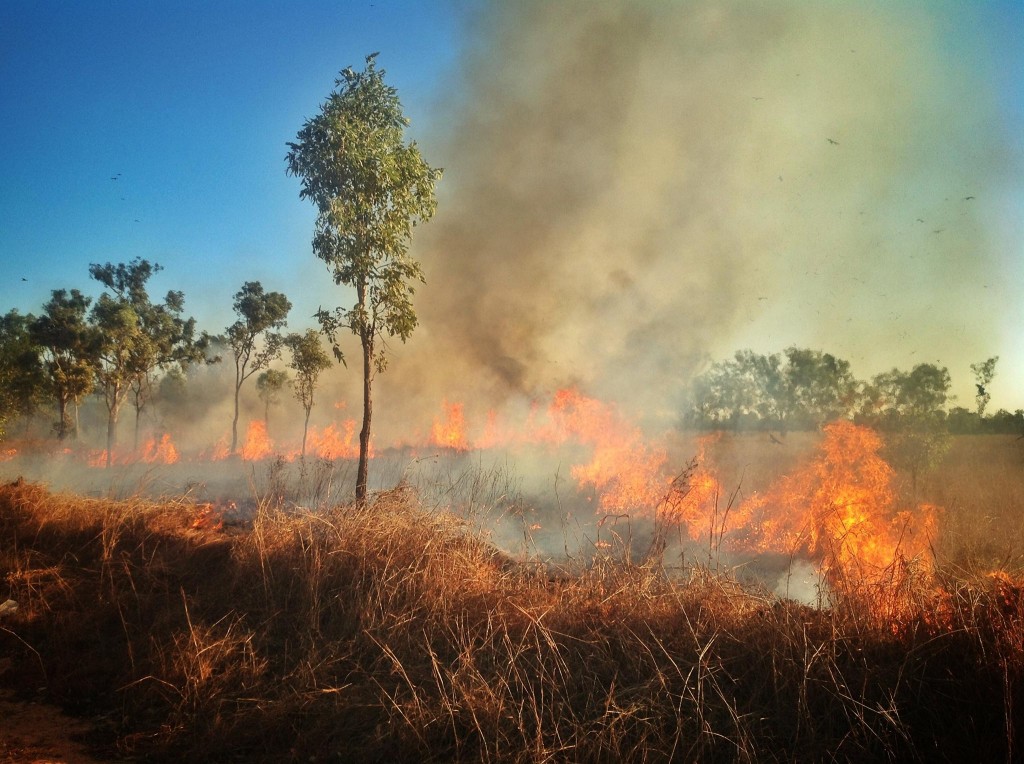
[0, 480, 1024, 762]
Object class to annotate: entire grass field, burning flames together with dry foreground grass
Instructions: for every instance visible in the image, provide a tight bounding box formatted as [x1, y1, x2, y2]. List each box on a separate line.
[0, 389, 1024, 761]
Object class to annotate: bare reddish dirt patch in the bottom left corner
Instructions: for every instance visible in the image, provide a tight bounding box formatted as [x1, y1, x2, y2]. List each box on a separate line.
[0, 690, 101, 764]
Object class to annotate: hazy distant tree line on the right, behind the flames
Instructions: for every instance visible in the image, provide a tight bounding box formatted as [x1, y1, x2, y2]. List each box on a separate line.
[683, 347, 1024, 434]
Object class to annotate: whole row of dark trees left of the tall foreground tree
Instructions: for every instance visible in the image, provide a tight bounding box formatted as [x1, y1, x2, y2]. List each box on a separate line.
[0, 258, 339, 466]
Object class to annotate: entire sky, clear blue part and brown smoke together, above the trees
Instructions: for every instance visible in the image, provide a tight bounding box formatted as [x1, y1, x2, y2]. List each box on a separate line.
[0, 0, 1024, 413]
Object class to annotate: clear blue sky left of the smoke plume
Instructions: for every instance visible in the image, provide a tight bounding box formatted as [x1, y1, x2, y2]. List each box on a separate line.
[0, 0, 459, 332]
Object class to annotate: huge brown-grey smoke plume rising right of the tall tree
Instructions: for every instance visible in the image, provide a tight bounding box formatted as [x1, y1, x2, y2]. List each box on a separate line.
[380, 0, 1007, 434]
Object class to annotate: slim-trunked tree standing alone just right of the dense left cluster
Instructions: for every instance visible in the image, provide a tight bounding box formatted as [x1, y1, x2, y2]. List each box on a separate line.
[226, 282, 292, 454]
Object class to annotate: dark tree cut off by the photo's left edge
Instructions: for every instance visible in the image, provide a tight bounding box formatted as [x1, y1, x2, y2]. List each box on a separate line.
[0, 309, 44, 437]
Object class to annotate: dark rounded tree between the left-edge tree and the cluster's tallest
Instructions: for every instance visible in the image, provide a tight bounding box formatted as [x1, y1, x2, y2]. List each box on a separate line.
[29, 289, 99, 440]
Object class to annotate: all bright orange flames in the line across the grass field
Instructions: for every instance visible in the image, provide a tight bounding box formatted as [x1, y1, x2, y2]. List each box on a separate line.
[0, 388, 938, 614]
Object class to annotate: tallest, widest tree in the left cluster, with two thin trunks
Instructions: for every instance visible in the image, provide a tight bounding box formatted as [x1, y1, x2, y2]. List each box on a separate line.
[89, 257, 213, 466]
